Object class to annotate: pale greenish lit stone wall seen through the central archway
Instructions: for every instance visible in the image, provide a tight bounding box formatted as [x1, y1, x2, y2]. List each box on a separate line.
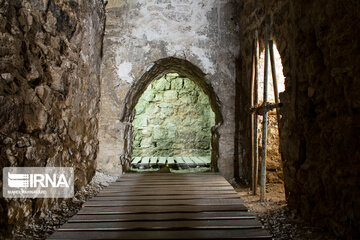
[132, 73, 215, 157]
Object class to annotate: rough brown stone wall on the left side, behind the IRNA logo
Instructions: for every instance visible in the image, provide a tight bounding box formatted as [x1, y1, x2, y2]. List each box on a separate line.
[0, 0, 105, 236]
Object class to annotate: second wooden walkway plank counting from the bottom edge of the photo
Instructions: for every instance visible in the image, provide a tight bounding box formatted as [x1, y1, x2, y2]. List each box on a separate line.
[59, 219, 262, 231]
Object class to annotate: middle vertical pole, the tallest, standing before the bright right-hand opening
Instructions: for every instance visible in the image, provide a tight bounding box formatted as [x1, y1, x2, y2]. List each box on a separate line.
[260, 15, 270, 202]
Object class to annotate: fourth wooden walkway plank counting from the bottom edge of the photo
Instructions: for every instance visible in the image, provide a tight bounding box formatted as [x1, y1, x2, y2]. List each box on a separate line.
[78, 204, 247, 214]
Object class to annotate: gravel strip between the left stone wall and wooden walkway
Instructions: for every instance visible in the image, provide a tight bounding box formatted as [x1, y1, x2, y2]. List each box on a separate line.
[14, 172, 118, 239]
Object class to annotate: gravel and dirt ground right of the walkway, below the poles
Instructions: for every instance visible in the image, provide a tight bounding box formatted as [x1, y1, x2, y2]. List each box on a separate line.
[235, 184, 337, 240]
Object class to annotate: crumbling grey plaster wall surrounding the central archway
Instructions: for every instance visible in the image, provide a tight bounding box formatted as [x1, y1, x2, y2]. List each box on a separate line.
[98, 0, 239, 178]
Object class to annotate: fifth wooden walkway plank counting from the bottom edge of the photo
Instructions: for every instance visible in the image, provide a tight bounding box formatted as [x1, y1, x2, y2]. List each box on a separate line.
[83, 198, 244, 207]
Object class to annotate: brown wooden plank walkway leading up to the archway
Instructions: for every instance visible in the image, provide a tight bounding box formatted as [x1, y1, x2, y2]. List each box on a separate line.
[49, 173, 271, 239]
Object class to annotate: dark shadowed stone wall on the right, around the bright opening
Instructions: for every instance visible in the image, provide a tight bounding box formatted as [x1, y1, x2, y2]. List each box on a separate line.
[237, 0, 360, 236]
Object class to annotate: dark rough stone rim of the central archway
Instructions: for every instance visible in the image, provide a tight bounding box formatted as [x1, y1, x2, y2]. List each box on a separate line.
[120, 57, 223, 171]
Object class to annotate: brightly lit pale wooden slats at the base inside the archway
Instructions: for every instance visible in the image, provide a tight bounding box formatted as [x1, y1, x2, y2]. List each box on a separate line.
[131, 156, 211, 169]
